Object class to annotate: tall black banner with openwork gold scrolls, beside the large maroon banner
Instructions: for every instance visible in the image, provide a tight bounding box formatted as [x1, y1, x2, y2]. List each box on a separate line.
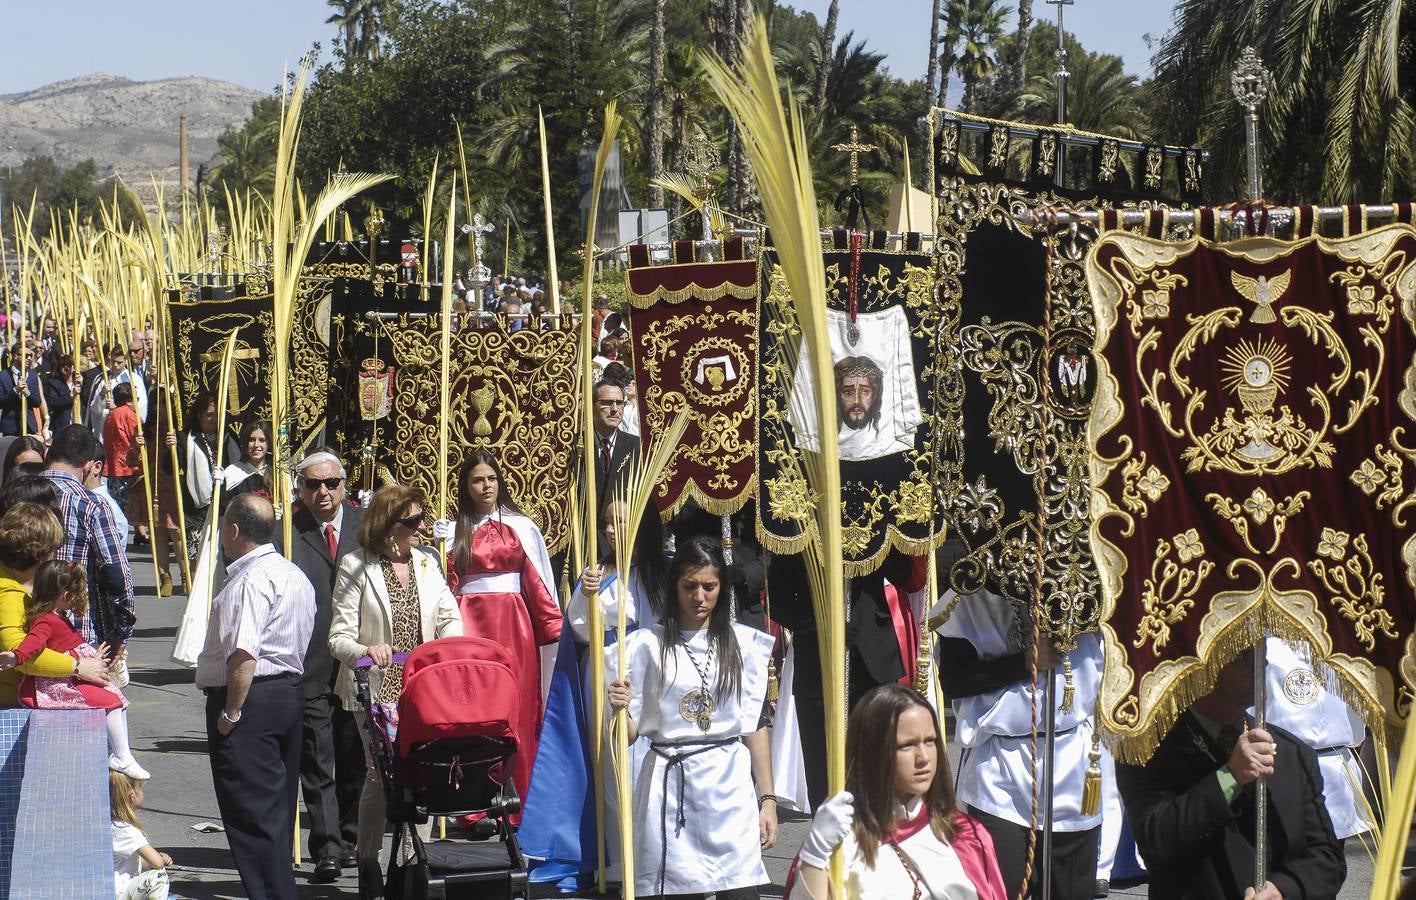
[932, 110, 1202, 651]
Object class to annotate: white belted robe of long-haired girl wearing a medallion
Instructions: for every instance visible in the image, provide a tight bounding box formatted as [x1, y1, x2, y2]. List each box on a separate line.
[610, 625, 773, 896]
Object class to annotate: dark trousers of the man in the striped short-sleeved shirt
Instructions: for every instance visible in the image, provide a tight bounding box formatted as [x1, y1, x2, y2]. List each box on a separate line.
[207, 675, 304, 900]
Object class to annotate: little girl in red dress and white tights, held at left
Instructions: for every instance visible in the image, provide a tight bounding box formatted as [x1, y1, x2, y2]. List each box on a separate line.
[0, 559, 152, 781]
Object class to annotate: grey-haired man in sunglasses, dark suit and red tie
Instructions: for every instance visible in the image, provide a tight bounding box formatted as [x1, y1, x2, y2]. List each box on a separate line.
[292, 449, 364, 883]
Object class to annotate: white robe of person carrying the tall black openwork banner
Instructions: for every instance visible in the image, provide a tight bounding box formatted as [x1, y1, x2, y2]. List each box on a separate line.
[939, 592, 1102, 832]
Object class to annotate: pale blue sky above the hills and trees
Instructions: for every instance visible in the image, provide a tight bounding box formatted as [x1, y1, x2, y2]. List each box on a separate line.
[0, 0, 1174, 93]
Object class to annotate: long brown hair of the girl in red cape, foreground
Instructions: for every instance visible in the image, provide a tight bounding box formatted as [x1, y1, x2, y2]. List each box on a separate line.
[845, 685, 957, 866]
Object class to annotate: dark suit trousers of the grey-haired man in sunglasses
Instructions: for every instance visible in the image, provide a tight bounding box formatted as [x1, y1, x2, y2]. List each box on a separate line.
[300, 693, 364, 859]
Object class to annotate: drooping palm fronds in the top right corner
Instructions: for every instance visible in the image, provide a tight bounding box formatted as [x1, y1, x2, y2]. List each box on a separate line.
[1154, 0, 1416, 202]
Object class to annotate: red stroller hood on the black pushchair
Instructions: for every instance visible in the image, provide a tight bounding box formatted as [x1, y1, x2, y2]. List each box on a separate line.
[398, 637, 521, 758]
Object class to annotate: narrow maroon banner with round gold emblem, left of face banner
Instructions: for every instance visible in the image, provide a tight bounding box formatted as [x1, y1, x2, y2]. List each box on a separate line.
[627, 239, 758, 521]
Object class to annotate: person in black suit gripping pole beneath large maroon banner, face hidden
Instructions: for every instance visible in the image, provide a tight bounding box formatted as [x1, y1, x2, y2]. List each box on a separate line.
[1116, 651, 1347, 900]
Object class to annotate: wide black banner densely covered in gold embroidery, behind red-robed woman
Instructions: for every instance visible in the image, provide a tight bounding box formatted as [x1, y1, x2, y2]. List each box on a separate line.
[381, 314, 581, 553]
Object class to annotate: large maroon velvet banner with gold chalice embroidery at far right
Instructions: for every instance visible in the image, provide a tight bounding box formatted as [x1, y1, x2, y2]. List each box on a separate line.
[1087, 225, 1416, 763]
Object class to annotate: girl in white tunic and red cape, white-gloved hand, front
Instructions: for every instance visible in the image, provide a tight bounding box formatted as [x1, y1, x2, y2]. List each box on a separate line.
[786, 685, 1007, 900]
